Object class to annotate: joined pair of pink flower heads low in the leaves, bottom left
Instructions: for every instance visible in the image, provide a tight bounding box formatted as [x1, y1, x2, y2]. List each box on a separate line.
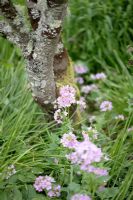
[33, 176, 61, 197]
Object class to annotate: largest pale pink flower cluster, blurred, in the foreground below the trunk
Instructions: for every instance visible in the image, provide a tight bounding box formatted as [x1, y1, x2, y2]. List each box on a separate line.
[61, 132, 107, 176]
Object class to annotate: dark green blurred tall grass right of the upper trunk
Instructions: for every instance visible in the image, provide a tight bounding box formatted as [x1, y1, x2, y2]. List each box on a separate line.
[64, 0, 133, 71]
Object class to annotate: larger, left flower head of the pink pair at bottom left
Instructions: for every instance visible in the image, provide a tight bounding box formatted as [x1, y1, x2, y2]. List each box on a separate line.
[34, 176, 55, 192]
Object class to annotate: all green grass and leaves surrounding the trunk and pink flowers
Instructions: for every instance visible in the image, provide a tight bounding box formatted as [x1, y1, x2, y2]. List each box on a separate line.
[0, 0, 133, 200]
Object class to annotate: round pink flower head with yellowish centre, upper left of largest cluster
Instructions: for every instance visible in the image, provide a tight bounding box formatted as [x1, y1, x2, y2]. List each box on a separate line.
[61, 132, 77, 148]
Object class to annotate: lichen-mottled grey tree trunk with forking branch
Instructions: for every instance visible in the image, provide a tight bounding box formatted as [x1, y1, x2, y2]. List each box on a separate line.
[0, 0, 69, 109]
